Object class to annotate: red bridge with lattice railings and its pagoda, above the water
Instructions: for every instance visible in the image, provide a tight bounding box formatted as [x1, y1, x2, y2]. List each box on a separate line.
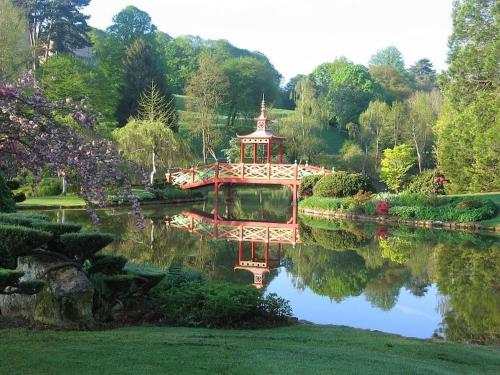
[165, 99, 328, 202]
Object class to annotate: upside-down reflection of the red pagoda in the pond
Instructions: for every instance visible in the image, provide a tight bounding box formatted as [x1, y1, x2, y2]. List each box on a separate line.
[234, 241, 281, 289]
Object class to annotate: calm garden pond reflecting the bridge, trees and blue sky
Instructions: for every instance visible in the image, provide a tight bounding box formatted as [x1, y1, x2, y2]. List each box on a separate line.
[31, 187, 500, 343]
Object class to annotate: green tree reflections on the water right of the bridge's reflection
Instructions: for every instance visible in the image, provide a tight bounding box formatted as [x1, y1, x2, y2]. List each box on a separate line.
[290, 220, 500, 343]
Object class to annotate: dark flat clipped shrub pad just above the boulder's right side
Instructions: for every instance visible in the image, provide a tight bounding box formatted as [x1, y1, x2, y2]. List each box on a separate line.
[58, 232, 114, 260]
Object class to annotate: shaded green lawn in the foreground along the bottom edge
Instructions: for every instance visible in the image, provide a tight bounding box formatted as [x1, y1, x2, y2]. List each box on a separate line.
[0, 325, 500, 375]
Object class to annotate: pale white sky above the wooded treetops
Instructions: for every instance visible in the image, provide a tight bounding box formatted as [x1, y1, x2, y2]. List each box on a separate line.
[84, 0, 452, 81]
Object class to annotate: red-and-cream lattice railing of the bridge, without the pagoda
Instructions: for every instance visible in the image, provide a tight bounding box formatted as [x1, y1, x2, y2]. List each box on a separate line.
[165, 163, 326, 186]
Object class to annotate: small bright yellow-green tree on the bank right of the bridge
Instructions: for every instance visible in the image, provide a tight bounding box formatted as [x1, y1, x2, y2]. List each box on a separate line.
[380, 144, 415, 192]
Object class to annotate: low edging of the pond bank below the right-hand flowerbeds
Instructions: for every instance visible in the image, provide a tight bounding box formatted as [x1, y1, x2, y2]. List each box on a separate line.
[299, 208, 500, 233]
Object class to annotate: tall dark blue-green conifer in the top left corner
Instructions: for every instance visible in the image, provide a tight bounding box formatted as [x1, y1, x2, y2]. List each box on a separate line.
[14, 0, 90, 69]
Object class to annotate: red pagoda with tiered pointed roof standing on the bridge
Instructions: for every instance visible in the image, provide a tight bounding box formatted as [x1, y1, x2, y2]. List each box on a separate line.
[236, 96, 286, 164]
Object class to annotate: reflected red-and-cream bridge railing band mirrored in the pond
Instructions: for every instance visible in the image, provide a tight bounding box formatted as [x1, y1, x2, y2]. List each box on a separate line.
[168, 212, 300, 244]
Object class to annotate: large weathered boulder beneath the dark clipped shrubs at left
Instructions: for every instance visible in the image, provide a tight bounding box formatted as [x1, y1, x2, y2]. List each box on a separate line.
[0, 255, 95, 329]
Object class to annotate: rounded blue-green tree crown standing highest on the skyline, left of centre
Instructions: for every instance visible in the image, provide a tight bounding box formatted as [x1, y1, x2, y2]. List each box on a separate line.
[107, 5, 156, 46]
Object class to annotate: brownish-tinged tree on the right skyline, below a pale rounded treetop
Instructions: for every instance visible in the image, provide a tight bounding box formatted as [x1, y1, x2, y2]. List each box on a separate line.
[370, 65, 413, 103]
